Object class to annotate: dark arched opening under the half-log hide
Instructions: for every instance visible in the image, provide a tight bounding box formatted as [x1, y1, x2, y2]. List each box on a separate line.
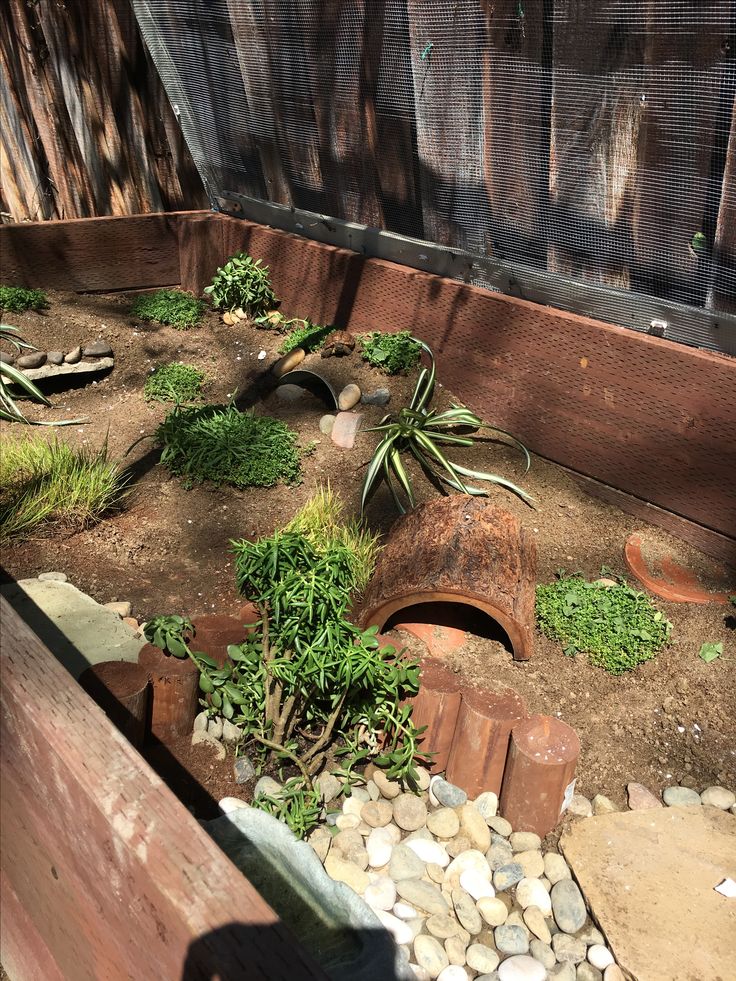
[382, 602, 513, 654]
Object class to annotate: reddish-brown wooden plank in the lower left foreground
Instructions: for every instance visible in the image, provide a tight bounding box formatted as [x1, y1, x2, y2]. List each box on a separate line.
[0, 598, 323, 981]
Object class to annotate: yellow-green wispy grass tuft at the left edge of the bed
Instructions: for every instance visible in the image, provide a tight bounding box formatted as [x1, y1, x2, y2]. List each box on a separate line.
[0, 436, 126, 542]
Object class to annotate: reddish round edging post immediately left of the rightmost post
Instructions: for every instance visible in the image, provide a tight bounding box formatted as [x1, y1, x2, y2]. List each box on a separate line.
[446, 688, 526, 799]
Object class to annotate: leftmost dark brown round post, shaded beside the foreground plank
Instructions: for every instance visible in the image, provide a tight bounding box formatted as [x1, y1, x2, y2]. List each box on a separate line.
[79, 661, 150, 748]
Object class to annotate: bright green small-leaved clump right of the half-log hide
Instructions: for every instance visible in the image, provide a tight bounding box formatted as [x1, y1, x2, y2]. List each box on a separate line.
[536, 575, 672, 675]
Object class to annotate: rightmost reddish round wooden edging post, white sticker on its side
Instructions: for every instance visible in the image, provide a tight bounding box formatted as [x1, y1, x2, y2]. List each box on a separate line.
[499, 715, 580, 838]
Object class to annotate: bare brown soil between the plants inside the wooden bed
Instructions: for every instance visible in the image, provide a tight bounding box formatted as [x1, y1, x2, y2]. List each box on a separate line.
[2, 292, 736, 809]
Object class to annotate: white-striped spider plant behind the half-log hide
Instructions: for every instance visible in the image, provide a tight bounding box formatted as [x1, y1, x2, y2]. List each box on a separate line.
[360, 341, 534, 514]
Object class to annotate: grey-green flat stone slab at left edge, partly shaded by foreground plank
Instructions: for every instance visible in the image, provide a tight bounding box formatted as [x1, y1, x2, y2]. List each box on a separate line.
[2, 579, 146, 678]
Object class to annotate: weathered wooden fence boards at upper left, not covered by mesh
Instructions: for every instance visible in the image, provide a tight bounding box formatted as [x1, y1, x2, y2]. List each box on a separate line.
[0, 0, 207, 221]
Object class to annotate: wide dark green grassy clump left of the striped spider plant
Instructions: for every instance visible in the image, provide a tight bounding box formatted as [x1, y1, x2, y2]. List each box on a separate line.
[155, 405, 301, 487]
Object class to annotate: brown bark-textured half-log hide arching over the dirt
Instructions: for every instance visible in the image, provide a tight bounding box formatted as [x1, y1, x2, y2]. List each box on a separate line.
[359, 494, 536, 661]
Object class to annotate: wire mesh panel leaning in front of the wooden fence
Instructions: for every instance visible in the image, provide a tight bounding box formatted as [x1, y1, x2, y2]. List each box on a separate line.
[134, 0, 736, 353]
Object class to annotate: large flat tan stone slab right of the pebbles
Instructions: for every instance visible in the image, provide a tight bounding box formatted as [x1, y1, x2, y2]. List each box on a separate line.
[560, 806, 736, 981]
